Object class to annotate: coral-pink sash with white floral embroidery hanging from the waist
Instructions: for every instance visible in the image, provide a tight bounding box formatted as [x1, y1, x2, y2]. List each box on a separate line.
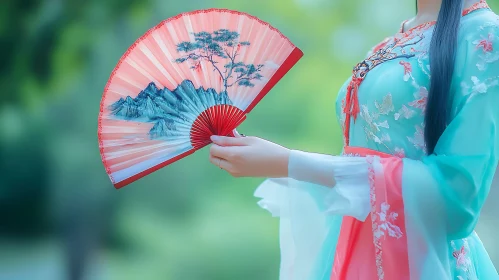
[330, 147, 410, 280]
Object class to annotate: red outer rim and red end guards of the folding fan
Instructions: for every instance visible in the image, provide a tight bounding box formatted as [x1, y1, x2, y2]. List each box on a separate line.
[97, 8, 303, 189]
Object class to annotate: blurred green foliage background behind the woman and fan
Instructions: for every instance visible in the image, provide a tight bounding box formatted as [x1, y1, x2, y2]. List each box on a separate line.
[0, 0, 499, 280]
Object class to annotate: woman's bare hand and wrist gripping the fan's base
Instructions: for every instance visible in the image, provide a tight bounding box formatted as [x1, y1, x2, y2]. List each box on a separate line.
[210, 134, 289, 178]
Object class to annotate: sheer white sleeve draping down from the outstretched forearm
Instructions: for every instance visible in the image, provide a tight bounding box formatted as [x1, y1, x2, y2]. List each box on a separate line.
[255, 153, 370, 280]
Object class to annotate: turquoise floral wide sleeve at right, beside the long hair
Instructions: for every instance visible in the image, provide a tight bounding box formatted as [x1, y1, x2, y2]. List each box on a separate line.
[400, 23, 499, 279]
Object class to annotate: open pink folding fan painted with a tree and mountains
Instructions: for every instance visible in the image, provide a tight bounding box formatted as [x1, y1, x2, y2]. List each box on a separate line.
[98, 9, 303, 188]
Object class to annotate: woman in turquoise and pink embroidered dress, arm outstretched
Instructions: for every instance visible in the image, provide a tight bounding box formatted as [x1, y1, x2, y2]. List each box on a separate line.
[210, 0, 499, 280]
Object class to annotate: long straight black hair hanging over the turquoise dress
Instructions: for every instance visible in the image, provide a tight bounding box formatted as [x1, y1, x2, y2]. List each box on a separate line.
[424, 0, 464, 154]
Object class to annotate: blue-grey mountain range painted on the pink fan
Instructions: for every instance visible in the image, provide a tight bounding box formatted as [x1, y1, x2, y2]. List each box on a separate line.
[109, 80, 232, 139]
